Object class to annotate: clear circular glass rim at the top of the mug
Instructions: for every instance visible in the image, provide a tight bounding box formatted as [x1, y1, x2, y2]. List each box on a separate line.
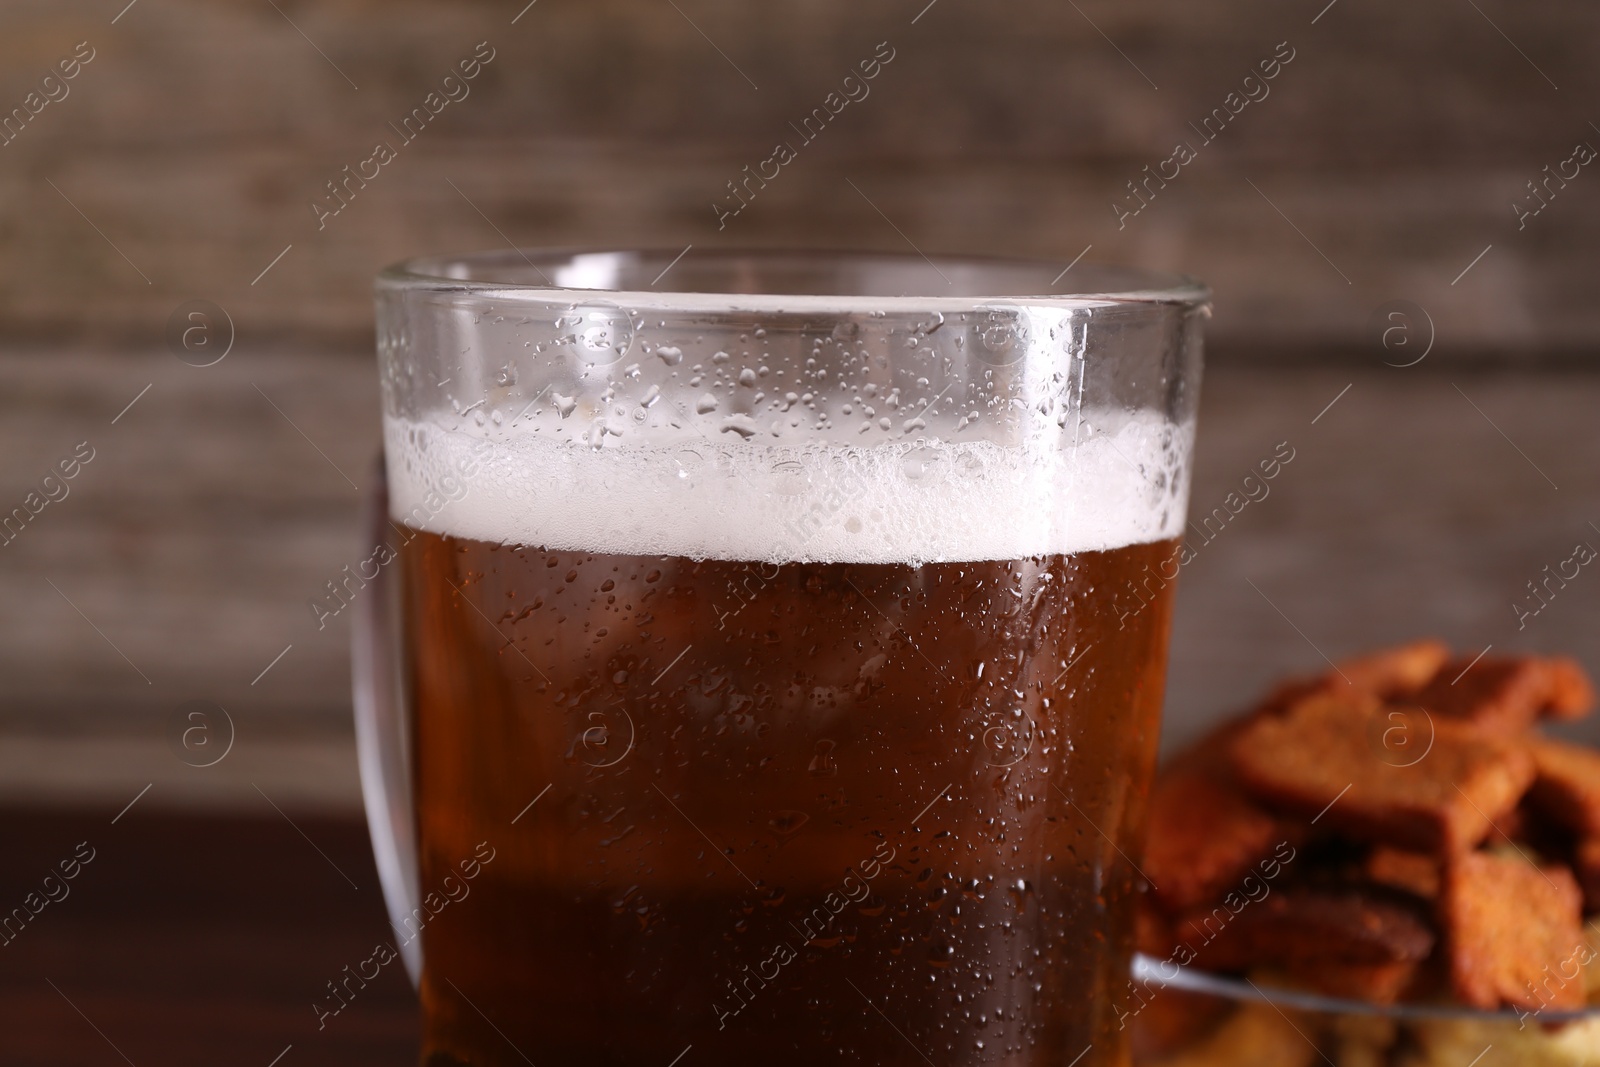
[374, 246, 1211, 315]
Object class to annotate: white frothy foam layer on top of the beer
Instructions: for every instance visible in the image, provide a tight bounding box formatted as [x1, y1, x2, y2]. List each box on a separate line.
[384, 413, 1194, 563]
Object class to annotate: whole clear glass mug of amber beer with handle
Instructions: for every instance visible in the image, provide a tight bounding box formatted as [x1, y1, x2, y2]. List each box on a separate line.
[355, 251, 1206, 1067]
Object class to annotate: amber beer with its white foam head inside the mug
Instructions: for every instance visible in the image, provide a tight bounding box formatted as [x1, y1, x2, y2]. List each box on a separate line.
[390, 415, 1182, 1067]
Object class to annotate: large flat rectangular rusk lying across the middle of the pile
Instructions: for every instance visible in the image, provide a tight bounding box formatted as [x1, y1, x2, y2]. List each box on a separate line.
[1232, 694, 1533, 854]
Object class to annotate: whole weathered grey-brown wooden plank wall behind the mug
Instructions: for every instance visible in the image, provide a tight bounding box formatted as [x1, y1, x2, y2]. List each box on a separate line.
[0, 0, 1600, 811]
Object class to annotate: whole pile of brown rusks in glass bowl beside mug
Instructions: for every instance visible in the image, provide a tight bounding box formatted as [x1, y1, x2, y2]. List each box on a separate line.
[1134, 641, 1600, 1067]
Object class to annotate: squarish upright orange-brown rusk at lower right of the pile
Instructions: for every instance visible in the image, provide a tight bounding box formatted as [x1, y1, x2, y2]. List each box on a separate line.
[1440, 853, 1587, 1011]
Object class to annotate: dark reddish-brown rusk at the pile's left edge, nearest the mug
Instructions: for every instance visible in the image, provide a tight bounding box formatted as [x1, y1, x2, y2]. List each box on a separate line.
[1144, 768, 1283, 913]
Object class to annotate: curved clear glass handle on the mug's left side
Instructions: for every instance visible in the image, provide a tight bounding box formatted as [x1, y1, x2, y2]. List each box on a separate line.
[350, 454, 422, 985]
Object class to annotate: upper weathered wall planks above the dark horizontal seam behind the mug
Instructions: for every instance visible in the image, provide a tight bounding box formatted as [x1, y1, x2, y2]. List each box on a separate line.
[0, 0, 1600, 357]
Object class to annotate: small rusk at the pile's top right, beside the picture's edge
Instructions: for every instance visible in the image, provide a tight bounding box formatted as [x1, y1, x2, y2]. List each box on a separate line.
[1411, 656, 1592, 737]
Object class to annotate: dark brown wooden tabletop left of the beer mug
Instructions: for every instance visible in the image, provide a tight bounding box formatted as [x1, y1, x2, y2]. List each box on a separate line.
[0, 801, 418, 1067]
